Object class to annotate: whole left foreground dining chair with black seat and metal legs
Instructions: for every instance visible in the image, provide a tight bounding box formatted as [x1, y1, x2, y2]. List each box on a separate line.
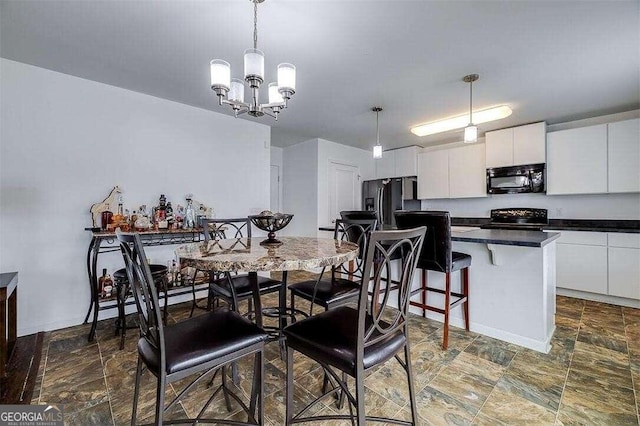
[116, 229, 267, 425]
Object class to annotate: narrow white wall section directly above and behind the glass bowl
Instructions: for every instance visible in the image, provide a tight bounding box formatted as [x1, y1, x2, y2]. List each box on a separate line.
[282, 139, 318, 237]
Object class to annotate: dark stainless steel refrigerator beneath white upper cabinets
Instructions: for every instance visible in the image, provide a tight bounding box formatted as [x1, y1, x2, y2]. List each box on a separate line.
[362, 176, 420, 228]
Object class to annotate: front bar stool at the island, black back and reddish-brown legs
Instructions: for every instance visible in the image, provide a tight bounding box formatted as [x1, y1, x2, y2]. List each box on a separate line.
[395, 211, 471, 349]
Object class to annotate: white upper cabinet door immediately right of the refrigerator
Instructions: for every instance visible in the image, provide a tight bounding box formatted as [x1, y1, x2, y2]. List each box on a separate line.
[418, 149, 449, 200]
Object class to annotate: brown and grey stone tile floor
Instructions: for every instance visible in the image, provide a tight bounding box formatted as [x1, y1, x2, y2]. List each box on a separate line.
[32, 273, 640, 425]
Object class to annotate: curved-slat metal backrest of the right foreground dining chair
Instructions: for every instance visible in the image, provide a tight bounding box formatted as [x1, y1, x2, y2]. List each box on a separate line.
[357, 226, 426, 354]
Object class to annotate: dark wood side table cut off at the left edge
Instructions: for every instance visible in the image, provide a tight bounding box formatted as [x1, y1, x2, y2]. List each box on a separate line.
[0, 272, 18, 379]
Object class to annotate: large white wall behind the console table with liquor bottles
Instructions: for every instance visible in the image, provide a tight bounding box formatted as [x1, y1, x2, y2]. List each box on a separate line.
[0, 59, 270, 335]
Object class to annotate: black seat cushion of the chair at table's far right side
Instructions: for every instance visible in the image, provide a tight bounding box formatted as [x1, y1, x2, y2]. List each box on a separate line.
[289, 278, 360, 307]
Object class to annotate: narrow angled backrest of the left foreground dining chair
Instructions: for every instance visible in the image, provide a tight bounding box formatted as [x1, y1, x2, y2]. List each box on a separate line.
[116, 228, 165, 362]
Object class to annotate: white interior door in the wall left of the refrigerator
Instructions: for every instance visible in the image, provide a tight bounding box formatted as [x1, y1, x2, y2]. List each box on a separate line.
[329, 162, 361, 223]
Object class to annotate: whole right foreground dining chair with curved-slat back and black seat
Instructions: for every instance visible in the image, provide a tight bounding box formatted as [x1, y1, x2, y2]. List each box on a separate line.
[284, 227, 425, 426]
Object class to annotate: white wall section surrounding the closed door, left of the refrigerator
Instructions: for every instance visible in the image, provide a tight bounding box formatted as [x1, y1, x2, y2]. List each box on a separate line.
[318, 139, 375, 230]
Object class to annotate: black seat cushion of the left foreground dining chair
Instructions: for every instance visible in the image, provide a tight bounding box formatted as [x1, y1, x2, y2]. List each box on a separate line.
[138, 311, 267, 375]
